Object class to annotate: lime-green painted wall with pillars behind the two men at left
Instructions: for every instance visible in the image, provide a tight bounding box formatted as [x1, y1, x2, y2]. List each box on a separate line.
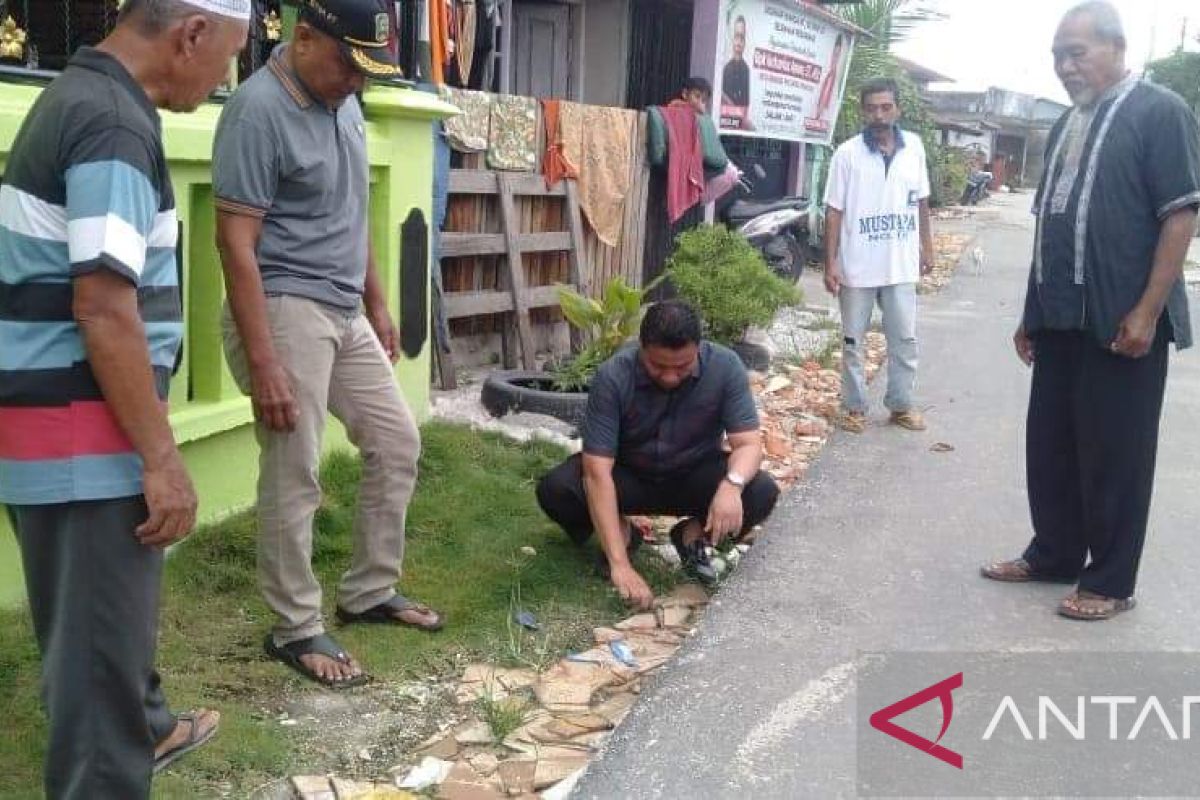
[0, 84, 456, 604]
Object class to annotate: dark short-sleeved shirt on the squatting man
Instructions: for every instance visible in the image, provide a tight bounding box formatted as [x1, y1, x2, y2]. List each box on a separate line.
[583, 342, 758, 475]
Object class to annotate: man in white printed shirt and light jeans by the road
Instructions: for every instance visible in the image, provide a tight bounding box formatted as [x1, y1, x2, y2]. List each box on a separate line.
[824, 78, 934, 433]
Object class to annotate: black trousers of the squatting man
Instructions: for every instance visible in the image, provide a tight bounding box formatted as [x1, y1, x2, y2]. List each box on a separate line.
[538, 453, 779, 545]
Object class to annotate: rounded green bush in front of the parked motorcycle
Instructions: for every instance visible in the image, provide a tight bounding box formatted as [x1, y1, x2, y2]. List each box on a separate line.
[666, 225, 803, 344]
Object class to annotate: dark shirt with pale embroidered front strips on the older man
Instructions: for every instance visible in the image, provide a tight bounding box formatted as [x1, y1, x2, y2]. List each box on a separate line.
[1025, 78, 1200, 349]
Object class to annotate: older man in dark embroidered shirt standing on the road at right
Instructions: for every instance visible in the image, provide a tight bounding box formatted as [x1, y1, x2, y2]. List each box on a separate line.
[983, 2, 1200, 620]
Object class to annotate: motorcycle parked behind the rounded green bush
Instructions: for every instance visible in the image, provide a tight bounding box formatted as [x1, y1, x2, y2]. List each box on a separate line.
[720, 164, 809, 282]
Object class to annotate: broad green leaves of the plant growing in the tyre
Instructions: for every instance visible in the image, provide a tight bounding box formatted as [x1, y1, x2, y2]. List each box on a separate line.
[553, 276, 662, 392]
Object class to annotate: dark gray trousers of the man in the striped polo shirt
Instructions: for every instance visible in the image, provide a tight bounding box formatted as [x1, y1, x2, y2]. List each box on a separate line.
[10, 497, 175, 800]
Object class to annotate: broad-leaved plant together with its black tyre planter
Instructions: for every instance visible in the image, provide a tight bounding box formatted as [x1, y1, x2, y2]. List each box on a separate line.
[480, 276, 661, 425]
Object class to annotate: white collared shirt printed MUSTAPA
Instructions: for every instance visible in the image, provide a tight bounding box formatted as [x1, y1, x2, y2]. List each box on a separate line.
[826, 131, 929, 289]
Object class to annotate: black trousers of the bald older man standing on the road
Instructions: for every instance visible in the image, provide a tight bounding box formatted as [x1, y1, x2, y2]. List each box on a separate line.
[1025, 326, 1170, 597]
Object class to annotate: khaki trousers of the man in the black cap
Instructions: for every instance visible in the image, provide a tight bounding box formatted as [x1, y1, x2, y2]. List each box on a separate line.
[222, 295, 420, 645]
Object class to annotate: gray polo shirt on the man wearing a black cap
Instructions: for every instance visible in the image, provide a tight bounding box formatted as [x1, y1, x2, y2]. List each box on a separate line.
[212, 46, 368, 309]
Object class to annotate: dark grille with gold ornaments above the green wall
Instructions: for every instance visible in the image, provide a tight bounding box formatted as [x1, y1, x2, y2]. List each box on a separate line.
[0, 0, 281, 79]
